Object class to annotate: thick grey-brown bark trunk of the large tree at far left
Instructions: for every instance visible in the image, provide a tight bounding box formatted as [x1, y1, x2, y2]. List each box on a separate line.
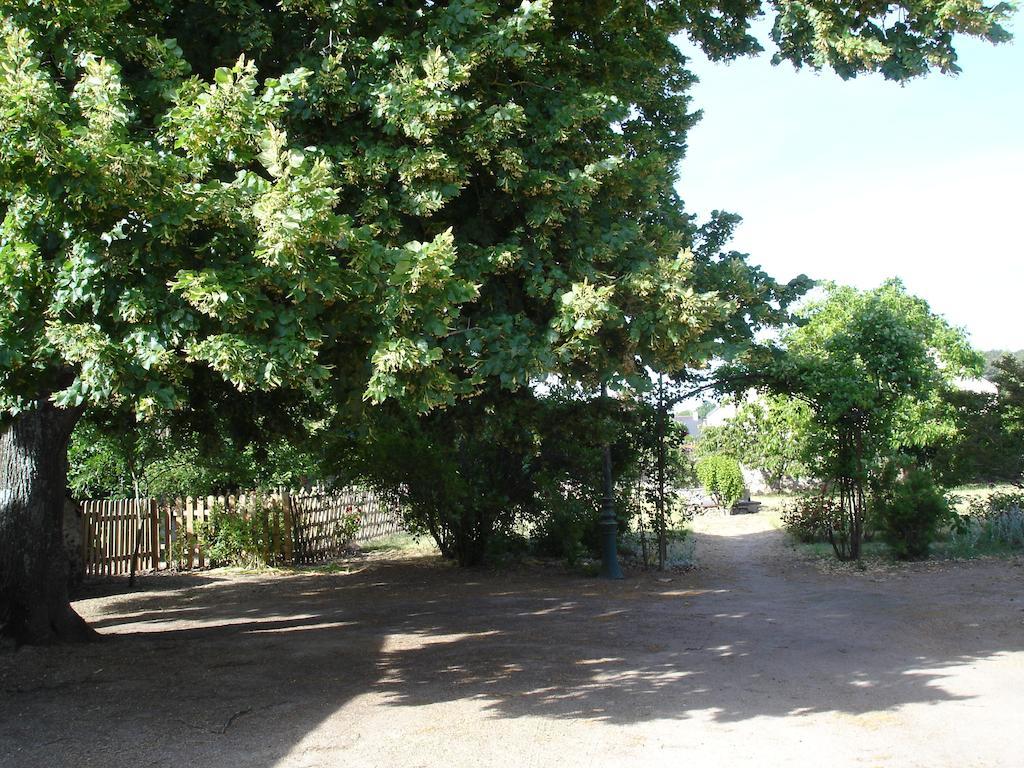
[0, 398, 95, 644]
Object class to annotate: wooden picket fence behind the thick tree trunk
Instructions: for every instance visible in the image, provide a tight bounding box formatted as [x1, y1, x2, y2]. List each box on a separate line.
[82, 487, 402, 577]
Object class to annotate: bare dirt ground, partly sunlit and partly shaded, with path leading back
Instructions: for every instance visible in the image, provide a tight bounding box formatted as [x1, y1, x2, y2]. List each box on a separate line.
[0, 515, 1024, 768]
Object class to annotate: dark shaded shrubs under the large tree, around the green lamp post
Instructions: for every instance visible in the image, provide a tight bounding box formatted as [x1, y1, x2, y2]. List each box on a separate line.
[341, 388, 663, 565]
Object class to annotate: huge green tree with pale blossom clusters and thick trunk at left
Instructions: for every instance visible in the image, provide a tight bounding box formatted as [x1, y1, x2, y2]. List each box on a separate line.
[0, 0, 1009, 641]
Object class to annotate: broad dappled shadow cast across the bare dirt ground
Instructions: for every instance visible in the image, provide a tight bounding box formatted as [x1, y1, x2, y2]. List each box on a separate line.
[0, 534, 1024, 768]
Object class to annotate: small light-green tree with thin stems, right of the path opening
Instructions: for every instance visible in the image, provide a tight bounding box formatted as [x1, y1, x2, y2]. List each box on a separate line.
[720, 280, 982, 560]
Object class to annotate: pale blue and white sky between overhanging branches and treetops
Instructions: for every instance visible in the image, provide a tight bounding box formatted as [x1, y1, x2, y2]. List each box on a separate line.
[678, 14, 1024, 349]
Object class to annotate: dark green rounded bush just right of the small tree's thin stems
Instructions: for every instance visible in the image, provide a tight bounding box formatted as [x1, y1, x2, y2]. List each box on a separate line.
[873, 469, 951, 560]
